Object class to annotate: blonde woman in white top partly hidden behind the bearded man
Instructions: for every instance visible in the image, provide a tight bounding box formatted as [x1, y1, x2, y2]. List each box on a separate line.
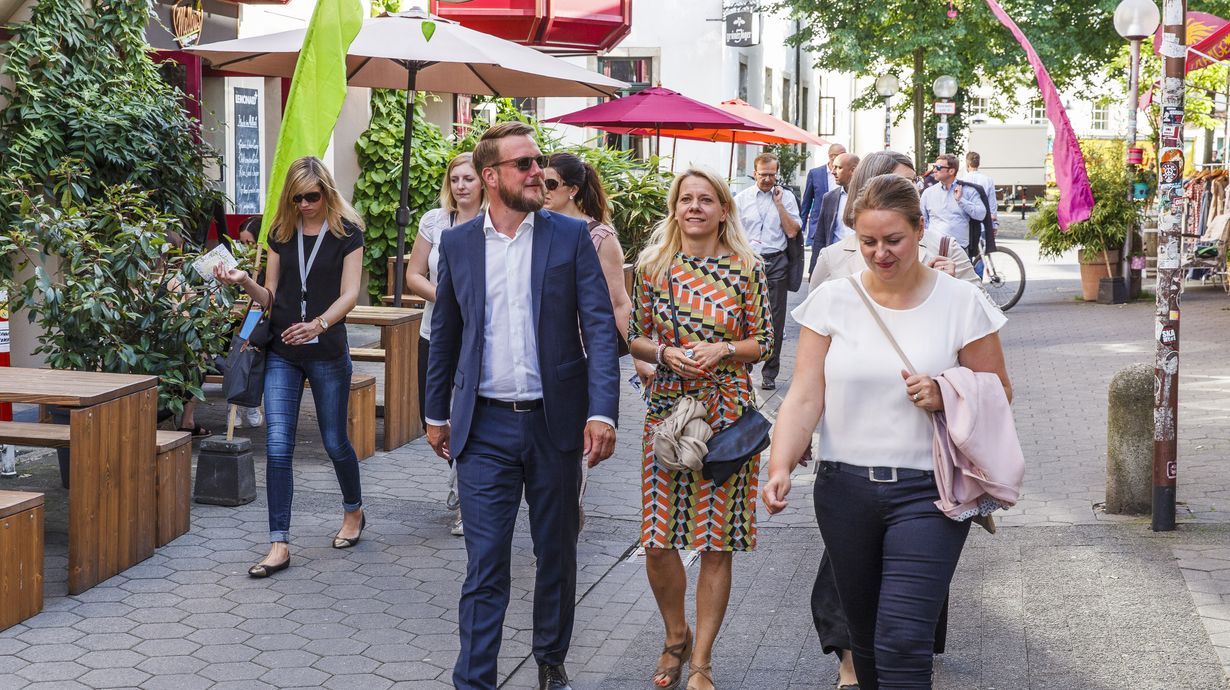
[406, 153, 485, 536]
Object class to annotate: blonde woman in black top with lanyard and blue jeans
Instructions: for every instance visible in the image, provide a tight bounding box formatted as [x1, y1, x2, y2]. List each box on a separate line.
[214, 156, 367, 577]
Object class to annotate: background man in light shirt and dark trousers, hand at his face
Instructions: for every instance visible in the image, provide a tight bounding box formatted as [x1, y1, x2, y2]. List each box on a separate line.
[734, 154, 803, 391]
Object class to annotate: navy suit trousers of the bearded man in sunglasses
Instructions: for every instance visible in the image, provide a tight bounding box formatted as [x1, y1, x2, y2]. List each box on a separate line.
[453, 402, 581, 690]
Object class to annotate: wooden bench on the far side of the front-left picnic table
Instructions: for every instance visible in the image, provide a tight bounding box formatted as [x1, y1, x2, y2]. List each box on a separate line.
[0, 422, 192, 546]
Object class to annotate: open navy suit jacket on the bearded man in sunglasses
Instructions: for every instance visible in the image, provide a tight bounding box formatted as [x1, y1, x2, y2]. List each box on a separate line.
[426, 210, 619, 458]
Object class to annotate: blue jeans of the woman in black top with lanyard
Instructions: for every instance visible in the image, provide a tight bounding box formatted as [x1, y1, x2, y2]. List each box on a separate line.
[264, 352, 363, 541]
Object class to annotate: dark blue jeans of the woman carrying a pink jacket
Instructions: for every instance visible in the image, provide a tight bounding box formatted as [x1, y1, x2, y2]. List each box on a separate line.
[815, 464, 969, 690]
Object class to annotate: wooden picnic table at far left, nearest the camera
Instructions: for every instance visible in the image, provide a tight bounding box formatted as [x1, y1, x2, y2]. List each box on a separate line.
[0, 368, 157, 594]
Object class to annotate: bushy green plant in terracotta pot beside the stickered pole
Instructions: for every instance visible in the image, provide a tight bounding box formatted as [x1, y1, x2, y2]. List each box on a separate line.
[1028, 143, 1140, 301]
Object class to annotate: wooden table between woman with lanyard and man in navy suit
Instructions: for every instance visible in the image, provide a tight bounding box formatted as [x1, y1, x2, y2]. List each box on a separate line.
[346, 306, 423, 450]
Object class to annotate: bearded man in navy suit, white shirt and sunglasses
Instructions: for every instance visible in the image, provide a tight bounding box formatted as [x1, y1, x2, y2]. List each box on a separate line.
[426, 122, 619, 690]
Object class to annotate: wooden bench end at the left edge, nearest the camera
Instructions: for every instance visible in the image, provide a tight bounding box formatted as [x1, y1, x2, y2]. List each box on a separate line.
[0, 491, 43, 630]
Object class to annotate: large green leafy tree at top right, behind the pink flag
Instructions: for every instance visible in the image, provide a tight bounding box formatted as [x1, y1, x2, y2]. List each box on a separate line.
[775, 0, 1230, 165]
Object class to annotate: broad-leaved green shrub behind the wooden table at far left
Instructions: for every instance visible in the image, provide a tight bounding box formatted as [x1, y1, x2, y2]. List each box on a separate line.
[0, 164, 234, 482]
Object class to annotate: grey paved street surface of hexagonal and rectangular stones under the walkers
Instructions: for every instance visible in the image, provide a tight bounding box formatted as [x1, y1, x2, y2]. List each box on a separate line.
[7, 240, 1230, 690]
